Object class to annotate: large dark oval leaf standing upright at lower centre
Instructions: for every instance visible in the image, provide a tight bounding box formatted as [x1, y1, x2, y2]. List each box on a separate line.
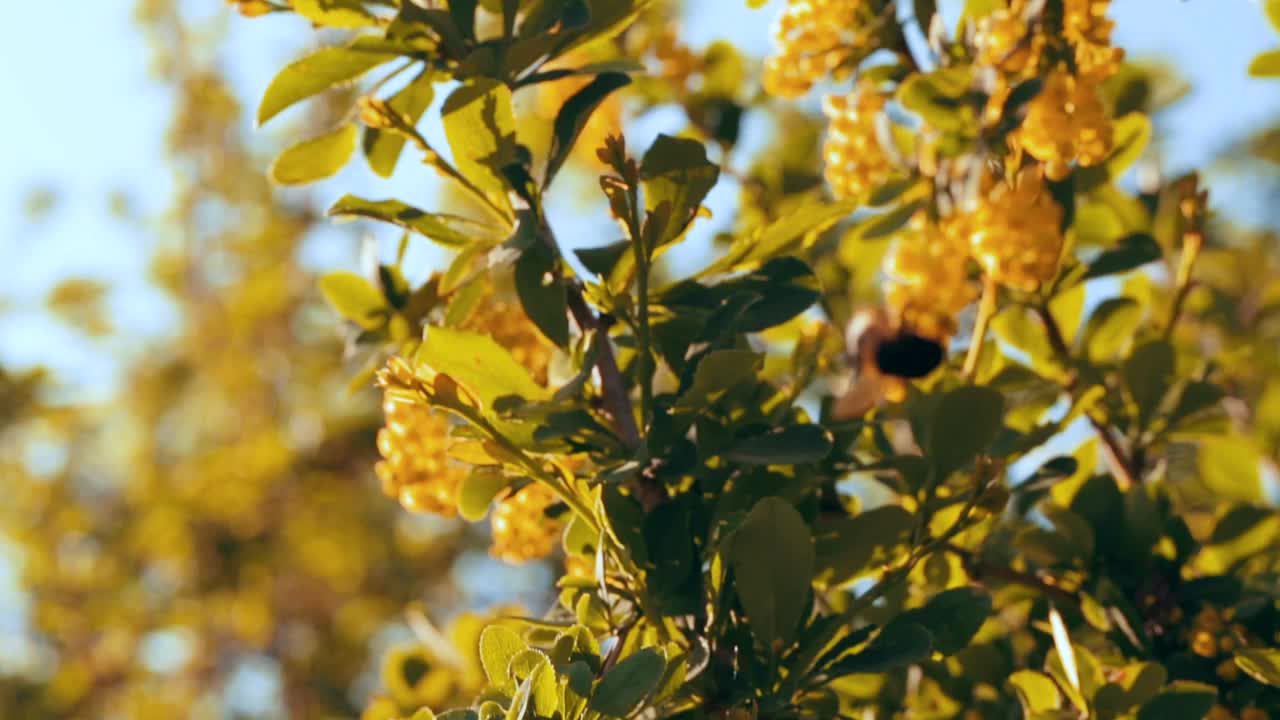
[730, 497, 814, 640]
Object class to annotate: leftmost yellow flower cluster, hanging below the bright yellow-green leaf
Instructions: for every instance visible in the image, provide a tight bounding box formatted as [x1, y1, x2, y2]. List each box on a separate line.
[375, 357, 466, 518]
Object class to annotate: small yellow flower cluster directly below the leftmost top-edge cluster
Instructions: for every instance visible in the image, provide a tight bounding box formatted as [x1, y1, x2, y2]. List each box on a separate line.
[822, 82, 893, 199]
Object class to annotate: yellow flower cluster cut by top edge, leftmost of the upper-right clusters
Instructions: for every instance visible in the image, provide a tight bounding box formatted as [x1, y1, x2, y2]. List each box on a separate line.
[762, 0, 864, 97]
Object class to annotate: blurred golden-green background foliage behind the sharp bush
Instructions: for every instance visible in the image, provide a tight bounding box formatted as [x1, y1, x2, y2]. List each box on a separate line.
[0, 0, 1280, 719]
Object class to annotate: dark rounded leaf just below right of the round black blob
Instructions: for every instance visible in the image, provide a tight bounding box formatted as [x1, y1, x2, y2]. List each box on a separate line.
[925, 386, 1005, 482]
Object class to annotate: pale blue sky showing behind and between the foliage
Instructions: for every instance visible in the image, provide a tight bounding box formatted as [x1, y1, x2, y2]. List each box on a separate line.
[0, 0, 1280, 396]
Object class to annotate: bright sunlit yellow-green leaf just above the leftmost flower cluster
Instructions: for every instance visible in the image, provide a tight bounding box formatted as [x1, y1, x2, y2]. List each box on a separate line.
[417, 327, 550, 409]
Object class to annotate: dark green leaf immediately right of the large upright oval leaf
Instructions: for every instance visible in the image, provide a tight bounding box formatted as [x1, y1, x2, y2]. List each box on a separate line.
[814, 505, 914, 585]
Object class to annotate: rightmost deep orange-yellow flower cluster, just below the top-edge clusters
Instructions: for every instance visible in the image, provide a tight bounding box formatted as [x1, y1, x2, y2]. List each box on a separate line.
[1018, 68, 1111, 178]
